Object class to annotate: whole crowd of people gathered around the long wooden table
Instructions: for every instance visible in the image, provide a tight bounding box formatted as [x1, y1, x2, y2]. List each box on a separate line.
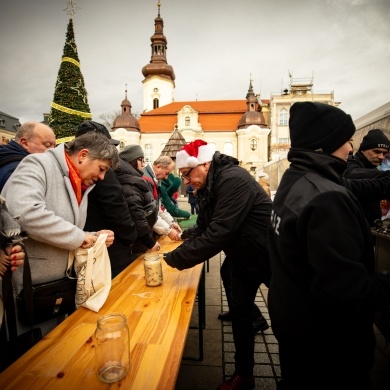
[0, 107, 390, 390]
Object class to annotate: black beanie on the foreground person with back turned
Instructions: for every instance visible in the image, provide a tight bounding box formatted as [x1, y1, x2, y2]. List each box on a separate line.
[289, 102, 356, 154]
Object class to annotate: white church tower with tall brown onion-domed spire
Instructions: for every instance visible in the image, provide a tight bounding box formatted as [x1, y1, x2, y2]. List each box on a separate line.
[142, 2, 175, 112]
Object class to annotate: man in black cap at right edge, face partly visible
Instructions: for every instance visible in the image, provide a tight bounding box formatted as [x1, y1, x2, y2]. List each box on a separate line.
[344, 129, 390, 226]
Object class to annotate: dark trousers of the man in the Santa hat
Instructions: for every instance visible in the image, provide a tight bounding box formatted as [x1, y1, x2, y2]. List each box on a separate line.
[221, 256, 262, 376]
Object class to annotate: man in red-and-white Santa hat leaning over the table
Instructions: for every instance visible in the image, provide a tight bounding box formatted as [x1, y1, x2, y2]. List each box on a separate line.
[164, 140, 272, 390]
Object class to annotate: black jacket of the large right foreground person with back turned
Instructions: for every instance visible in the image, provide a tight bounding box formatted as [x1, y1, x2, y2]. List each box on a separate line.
[268, 149, 390, 370]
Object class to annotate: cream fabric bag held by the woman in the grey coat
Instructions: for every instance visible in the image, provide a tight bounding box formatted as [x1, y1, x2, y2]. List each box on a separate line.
[67, 234, 111, 312]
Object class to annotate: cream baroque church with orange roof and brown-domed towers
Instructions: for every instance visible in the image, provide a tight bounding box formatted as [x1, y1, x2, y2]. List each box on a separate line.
[111, 5, 271, 170]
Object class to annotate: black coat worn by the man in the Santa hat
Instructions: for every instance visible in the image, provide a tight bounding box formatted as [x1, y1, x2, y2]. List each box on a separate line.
[165, 152, 272, 284]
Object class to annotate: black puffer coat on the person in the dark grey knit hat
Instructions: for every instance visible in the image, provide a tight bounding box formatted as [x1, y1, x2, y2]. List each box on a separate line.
[115, 159, 158, 252]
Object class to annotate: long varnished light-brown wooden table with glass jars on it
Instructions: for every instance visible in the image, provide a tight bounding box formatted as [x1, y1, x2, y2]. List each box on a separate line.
[0, 237, 203, 390]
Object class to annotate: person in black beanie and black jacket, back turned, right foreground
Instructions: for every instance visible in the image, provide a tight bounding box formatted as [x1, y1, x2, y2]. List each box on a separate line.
[268, 102, 390, 390]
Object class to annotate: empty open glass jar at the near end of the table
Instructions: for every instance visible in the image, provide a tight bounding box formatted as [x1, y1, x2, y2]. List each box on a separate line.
[95, 313, 130, 383]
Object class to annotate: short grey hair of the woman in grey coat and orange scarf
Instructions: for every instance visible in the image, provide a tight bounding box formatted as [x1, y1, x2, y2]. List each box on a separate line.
[65, 131, 119, 169]
